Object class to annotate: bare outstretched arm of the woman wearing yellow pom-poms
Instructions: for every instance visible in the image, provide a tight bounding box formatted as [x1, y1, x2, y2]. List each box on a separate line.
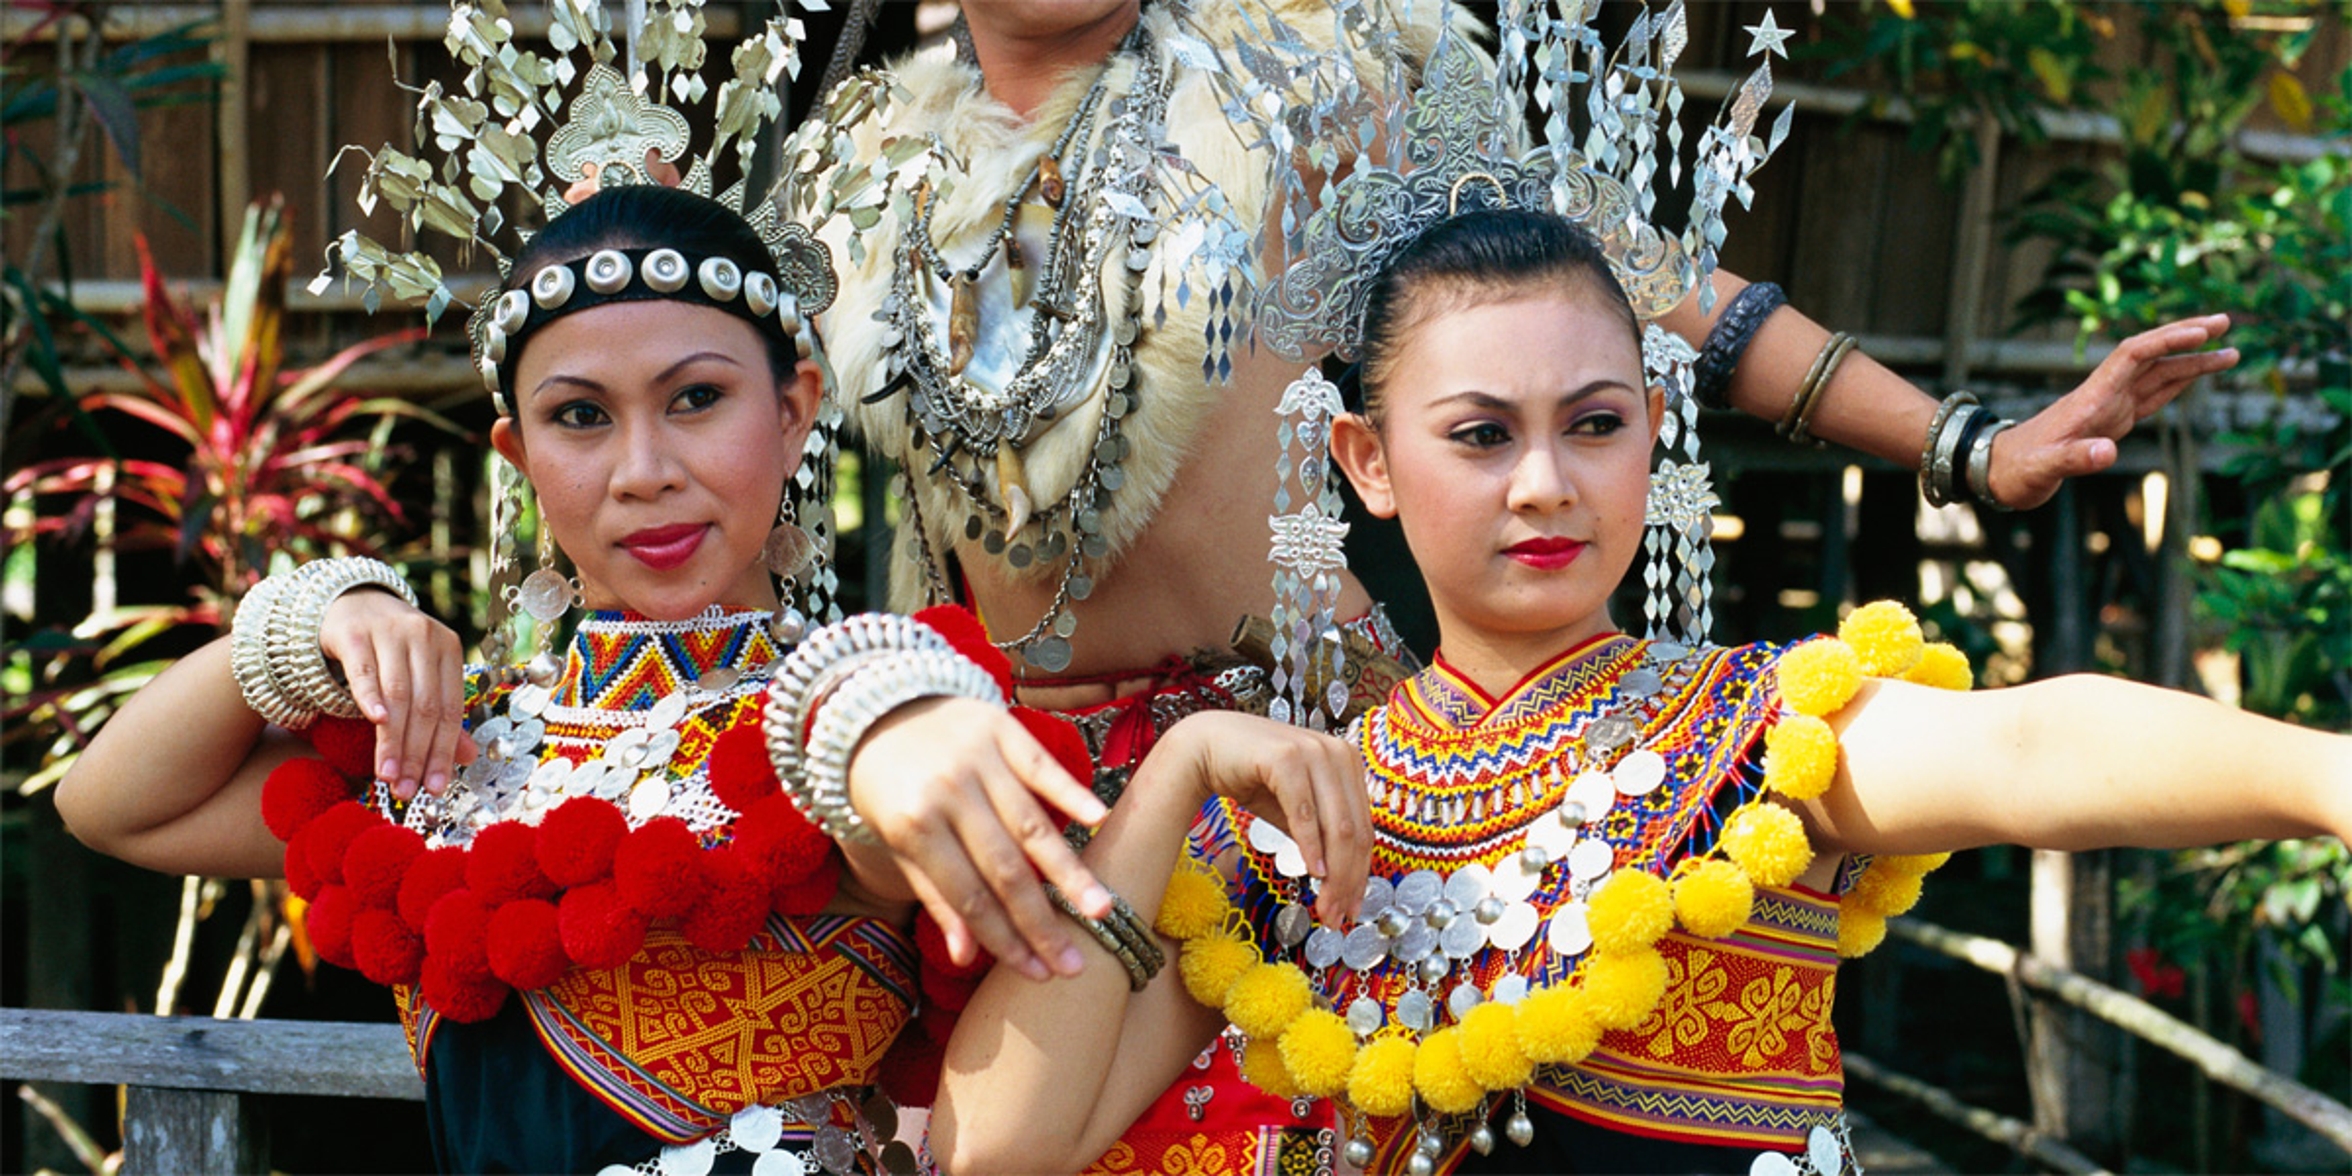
[1802, 675, 2352, 854]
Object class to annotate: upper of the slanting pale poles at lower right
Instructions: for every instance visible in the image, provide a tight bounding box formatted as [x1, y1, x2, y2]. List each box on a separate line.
[1881, 920, 2352, 1152]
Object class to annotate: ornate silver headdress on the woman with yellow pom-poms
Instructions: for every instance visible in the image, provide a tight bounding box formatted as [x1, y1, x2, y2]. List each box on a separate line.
[1225, 0, 1790, 642]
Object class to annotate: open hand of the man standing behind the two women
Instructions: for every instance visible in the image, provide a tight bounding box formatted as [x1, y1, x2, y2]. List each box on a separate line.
[1992, 315, 2237, 510]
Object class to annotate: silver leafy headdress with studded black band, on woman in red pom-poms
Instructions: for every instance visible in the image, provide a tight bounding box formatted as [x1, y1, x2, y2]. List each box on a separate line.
[310, 0, 889, 659]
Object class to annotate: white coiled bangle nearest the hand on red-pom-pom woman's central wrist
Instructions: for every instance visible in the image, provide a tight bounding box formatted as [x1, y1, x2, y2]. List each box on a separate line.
[783, 649, 1004, 842]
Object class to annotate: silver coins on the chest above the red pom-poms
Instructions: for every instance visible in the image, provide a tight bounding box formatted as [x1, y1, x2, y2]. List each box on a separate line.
[388, 607, 769, 847]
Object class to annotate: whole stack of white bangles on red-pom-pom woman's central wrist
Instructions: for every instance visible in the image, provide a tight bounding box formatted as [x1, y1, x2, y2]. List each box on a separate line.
[764, 614, 1004, 842]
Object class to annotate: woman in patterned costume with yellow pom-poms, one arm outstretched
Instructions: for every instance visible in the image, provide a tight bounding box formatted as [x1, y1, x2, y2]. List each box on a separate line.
[931, 204, 2352, 1176]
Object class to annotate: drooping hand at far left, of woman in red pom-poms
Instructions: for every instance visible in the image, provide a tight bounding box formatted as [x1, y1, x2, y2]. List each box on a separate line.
[318, 588, 475, 800]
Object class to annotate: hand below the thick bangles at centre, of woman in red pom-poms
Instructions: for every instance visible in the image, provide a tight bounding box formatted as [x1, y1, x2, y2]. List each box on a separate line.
[849, 699, 1110, 981]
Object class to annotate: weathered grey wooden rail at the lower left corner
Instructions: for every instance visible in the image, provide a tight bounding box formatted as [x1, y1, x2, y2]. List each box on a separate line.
[0, 1009, 426, 1101]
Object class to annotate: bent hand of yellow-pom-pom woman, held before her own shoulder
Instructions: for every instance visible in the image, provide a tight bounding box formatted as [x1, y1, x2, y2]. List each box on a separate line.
[1152, 710, 1371, 924]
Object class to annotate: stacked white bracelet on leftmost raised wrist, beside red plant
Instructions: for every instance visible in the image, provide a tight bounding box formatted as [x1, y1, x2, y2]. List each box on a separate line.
[228, 555, 416, 729]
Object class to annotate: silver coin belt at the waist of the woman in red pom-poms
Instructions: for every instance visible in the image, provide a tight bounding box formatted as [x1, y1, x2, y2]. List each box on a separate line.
[597, 1091, 922, 1176]
